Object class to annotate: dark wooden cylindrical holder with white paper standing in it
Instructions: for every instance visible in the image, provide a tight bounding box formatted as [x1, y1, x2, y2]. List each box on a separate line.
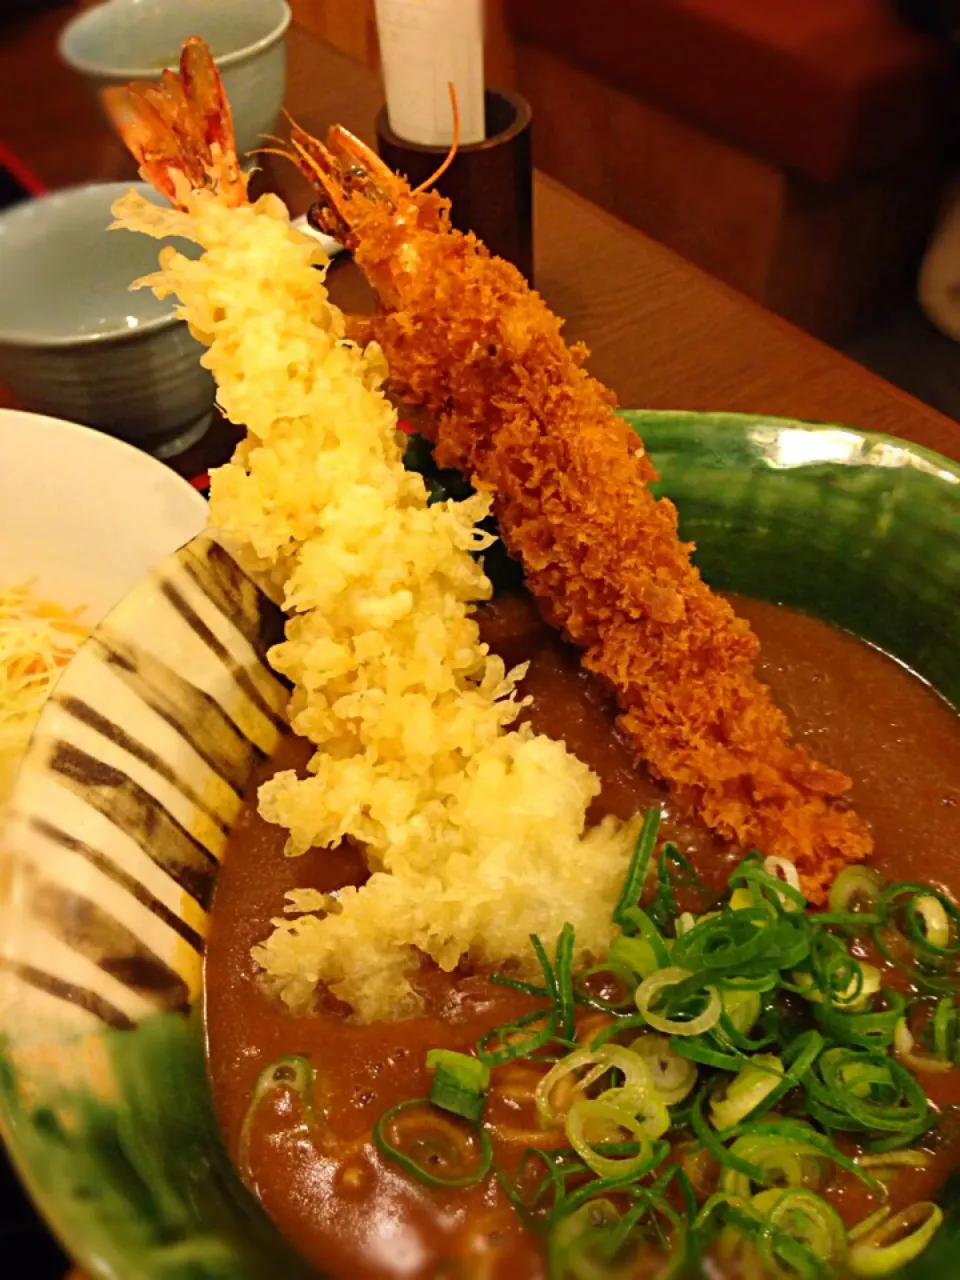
[376, 90, 534, 284]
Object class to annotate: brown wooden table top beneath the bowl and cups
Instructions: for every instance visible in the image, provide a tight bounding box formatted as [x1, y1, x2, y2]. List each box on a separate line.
[0, 4, 960, 1280]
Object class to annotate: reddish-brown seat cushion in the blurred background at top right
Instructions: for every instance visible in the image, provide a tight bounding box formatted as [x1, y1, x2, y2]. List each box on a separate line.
[509, 0, 948, 183]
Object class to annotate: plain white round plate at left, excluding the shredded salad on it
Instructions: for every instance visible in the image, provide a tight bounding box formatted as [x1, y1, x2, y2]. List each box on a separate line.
[0, 410, 206, 623]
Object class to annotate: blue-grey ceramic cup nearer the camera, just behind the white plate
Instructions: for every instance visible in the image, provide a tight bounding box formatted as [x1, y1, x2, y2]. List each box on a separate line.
[0, 182, 214, 457]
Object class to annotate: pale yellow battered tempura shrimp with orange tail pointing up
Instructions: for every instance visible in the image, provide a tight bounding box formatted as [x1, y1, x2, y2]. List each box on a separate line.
[104, 37, 639, 1020]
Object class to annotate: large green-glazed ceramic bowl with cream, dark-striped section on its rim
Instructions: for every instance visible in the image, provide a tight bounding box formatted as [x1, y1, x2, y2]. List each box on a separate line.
[0, 412, 960, 1280]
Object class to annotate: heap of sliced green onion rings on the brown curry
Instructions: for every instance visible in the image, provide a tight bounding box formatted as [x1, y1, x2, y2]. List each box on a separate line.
[371, 810, 960, 1280]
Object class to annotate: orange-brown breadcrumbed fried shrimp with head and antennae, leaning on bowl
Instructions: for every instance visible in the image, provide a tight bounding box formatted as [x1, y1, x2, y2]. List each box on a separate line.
[294, 131, 872, 901]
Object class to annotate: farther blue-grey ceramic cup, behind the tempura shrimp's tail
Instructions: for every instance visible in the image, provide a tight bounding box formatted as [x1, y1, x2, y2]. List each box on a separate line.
[60, 0, 291, 156]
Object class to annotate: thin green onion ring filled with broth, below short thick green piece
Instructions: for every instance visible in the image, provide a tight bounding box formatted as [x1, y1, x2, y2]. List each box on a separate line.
[374, 1098, 493, 1189]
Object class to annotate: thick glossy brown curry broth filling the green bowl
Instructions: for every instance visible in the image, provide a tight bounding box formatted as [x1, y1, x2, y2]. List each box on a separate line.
[206, 598, 960, 1280]
